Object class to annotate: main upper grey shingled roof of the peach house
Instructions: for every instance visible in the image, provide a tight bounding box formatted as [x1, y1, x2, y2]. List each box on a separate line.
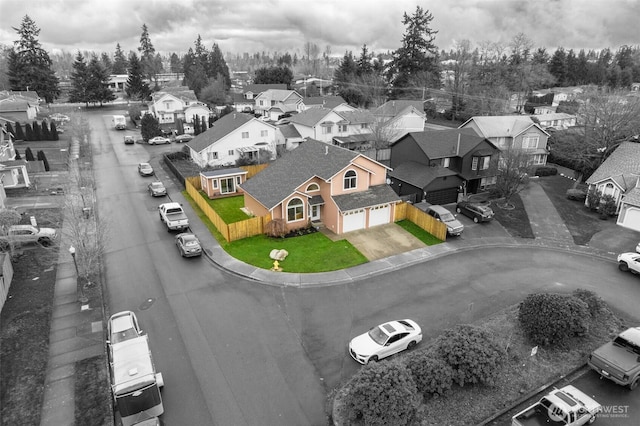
[241, 139, 382, 210]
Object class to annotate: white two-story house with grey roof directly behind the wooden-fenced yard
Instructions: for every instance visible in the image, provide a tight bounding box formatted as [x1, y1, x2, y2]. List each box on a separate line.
[186, 112, 276, 167]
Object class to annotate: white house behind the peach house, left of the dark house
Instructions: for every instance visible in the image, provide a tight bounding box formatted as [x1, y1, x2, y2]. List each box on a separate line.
[288, 107, 375, 144]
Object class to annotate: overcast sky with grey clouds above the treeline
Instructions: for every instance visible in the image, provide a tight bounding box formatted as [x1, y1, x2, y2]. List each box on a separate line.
[0, 0, 640, 56]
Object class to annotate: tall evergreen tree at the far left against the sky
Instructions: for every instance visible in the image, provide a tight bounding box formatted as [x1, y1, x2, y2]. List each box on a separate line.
[7, 15, 60, 103]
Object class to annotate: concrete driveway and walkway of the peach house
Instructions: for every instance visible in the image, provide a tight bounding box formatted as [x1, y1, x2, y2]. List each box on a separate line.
[321, 223, 426, 261]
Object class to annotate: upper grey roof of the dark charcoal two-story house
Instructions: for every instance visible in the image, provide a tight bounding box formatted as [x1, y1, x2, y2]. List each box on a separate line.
[402, 128, 497, 159]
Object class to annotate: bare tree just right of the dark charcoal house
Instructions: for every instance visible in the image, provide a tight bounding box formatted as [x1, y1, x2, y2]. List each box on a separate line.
[496, 148, 531, 206]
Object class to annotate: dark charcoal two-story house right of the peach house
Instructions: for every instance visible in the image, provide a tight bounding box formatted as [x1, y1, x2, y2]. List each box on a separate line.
[388, 129, 500, 204]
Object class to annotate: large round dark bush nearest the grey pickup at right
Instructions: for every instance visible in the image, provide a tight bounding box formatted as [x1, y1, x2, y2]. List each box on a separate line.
[518, 293, 590, 346]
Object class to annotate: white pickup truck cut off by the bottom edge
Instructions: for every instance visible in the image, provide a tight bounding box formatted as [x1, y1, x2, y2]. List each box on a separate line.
[511, 385, 602, 426]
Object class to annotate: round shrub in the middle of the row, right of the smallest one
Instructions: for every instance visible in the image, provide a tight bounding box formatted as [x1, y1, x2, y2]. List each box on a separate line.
[435, 325, 506, 386]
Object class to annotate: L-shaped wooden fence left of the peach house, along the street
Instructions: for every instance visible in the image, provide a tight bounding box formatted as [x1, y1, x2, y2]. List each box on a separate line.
[184, 177, 271, 242]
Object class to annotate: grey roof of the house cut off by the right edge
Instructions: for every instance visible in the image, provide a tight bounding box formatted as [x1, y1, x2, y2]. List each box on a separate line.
[587, 142, 640, 189]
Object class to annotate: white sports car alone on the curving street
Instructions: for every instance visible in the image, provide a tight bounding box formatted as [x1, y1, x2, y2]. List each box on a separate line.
[349, 319, 422, 364]
